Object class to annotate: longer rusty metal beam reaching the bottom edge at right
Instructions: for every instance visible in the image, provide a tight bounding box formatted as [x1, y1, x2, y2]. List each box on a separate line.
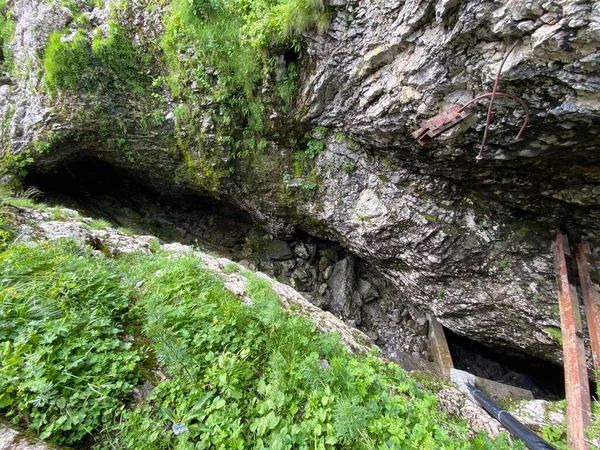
[552, 230, 592, 450]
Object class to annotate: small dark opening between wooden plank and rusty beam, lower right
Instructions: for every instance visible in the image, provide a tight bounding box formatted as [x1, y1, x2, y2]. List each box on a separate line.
[444, 328, 565, 400]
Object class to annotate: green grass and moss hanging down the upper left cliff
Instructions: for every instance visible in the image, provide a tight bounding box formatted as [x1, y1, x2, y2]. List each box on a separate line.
[19, 0, 330, 191]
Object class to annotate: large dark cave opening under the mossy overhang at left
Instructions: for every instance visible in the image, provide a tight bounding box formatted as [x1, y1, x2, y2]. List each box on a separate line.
[25, 158, 256, 257]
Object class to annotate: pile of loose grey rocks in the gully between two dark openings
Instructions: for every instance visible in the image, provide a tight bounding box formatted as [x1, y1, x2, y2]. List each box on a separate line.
[227, 234, 428, 359]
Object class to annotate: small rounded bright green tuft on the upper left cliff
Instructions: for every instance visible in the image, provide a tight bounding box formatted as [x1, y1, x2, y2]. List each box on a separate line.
[43, 29, 91, 94]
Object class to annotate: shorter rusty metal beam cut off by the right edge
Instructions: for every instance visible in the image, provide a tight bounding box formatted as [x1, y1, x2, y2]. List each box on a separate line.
[575, 242, 600, 379]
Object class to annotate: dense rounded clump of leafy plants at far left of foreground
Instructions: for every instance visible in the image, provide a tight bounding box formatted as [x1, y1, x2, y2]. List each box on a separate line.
[0, 242, 140, 443]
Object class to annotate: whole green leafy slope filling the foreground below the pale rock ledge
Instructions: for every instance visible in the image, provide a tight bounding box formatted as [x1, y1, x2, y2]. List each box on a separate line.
[0, 214, 524, 449]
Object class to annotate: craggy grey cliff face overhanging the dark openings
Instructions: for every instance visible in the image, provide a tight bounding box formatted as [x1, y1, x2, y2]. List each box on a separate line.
[0, 0, 600, 370]
